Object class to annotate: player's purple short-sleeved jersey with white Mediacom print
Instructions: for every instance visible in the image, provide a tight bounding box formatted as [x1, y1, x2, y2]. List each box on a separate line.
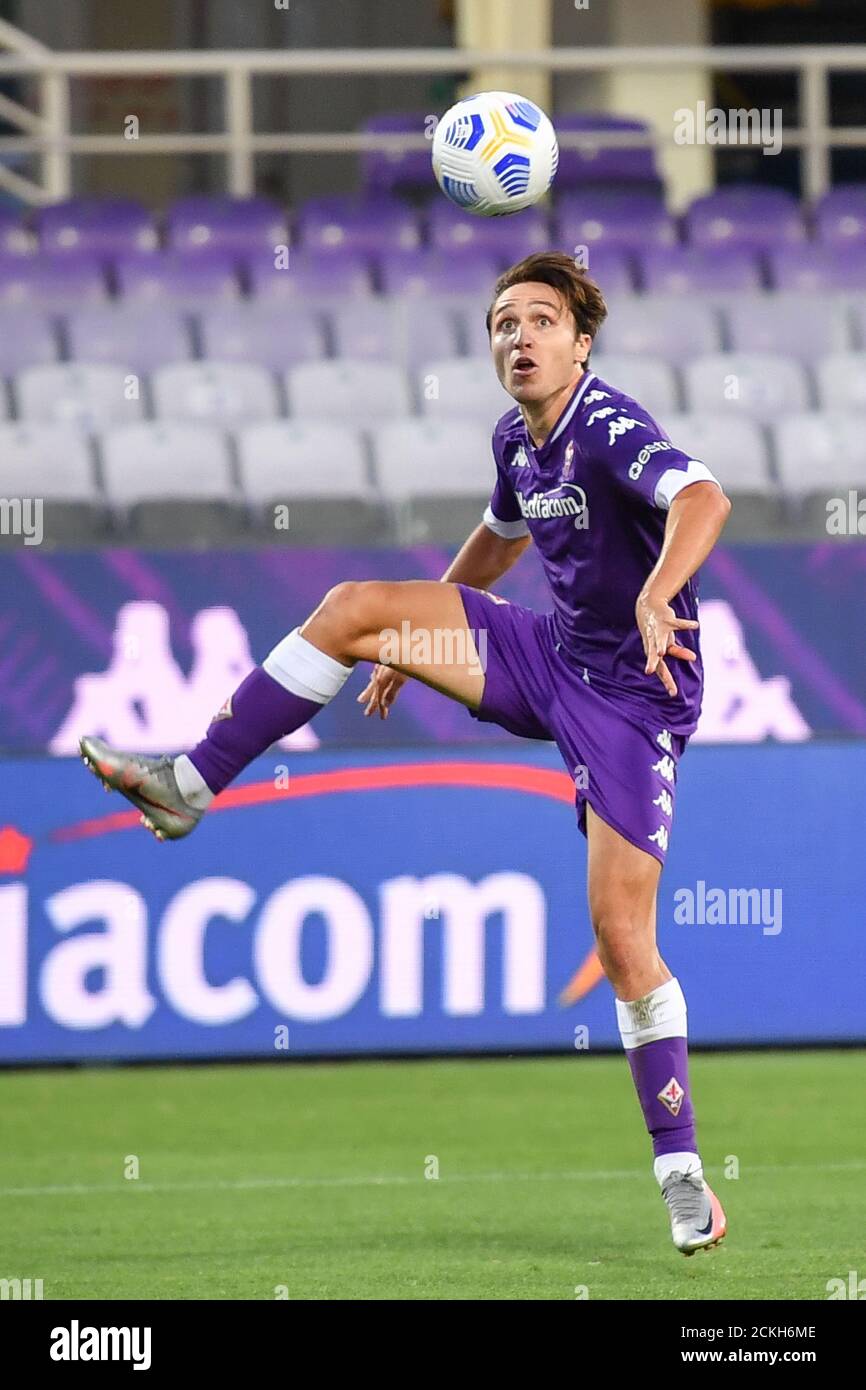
[484, 371, 717, 734]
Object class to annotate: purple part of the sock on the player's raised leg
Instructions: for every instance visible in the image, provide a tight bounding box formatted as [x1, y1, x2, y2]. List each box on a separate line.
[188, 666, 324, 792]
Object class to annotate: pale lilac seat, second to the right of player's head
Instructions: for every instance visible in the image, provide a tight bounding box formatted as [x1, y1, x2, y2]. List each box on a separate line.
[723, 293, 851, 363]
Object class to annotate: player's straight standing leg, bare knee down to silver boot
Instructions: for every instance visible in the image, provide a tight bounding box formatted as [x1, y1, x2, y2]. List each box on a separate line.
[587, 806, 726, 1255]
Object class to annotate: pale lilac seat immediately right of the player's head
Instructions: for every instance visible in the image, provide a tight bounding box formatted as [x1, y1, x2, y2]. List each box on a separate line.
[596, 295, 721, 363]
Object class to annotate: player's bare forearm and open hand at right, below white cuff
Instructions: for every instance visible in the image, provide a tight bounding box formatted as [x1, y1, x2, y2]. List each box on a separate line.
[635, 482, 731, 695]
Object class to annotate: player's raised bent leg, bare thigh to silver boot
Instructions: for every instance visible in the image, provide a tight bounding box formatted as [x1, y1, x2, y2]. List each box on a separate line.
[81, 580, 484, 840]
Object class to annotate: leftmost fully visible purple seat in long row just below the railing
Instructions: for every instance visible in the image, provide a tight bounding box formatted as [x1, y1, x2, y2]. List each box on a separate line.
[33, 197, 158, 256]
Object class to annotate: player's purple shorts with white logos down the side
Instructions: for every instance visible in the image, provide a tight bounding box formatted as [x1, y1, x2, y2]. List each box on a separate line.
[457, 584, 688, 863]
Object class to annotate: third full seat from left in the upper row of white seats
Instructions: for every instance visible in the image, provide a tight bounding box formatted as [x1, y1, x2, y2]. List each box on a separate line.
[285, 357, 411, 430]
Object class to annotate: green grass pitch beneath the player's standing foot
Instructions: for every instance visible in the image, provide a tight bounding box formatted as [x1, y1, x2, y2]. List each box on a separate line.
[0, 1051, 866, 1300]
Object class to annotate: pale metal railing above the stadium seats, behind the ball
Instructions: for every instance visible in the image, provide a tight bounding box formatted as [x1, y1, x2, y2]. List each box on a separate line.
[0, 21, 866, 203]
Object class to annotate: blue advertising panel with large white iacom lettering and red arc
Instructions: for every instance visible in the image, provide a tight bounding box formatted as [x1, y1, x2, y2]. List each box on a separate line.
[0, 742, 866, 1062]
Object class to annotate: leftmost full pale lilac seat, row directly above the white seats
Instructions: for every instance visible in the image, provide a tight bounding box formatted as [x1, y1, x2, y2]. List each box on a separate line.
[65, 304, 190, 373]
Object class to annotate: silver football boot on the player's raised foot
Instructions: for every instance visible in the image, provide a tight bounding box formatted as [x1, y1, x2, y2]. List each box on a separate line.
[78, 734, 204, 840]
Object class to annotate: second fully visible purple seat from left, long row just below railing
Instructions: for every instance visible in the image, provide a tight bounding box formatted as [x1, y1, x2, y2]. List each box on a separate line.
[165, 197, 289, 253]
